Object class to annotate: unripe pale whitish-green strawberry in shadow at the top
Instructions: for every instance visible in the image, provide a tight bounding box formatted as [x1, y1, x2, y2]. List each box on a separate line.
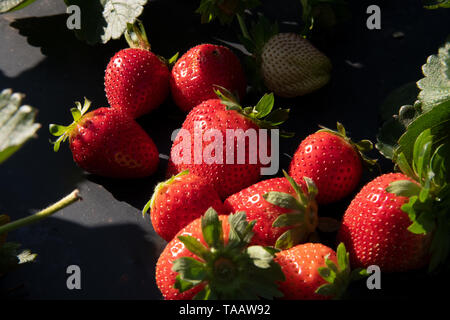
[261, 33, 331, 98]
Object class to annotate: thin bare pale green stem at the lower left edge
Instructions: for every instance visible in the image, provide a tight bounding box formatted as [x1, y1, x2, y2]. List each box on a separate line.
[0, 189, 80, 234]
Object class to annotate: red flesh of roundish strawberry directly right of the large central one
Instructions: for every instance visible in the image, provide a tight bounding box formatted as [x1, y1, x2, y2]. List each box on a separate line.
[289, 132, 362, 205]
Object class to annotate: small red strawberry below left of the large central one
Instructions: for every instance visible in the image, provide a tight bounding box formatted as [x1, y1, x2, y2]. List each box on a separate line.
[142, 171, 226, 241]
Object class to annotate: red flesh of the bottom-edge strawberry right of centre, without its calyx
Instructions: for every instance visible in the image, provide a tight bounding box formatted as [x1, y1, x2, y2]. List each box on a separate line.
[275, 243, 337, 300]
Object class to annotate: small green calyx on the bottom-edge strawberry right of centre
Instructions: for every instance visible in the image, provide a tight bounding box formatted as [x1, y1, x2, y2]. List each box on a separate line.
[316, 243, 368, 299]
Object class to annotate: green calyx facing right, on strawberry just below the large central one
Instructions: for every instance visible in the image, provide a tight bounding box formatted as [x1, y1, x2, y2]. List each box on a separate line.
[263, 170, 319, 250]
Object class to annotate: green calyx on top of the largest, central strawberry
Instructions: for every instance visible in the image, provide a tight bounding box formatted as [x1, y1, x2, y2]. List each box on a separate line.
[214, 85, 294, 138]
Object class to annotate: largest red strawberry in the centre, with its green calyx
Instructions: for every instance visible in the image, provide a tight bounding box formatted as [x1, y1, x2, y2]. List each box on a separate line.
[169, 91, 288, 199]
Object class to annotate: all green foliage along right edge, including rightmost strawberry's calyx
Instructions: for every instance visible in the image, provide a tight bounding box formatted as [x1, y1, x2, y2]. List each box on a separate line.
[376, 42, 450, 270]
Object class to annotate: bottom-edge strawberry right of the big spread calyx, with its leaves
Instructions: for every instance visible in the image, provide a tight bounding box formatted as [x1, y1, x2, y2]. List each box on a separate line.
[275, 243, 367, 300]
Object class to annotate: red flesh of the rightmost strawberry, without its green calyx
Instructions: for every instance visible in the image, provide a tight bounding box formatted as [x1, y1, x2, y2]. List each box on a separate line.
[338, 173, 429, 272]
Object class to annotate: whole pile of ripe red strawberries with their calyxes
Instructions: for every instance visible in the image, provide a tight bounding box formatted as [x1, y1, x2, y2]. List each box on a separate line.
[50, 22, 430, 299]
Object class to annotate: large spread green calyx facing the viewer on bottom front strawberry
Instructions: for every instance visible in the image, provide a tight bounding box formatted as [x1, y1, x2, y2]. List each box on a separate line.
[172, 208, 284, 300]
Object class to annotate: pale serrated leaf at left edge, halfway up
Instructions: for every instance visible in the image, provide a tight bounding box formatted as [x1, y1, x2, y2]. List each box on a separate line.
[0, 89, 41, 163]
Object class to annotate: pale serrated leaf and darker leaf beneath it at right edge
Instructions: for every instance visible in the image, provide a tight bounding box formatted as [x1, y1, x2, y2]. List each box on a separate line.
[376, 42, 450, 165]
